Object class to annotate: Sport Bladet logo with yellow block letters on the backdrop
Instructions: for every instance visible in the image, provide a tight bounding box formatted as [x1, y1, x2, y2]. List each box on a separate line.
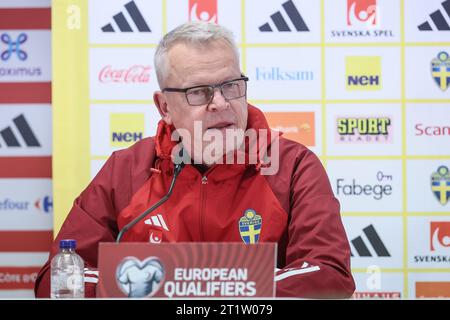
[335, 117, 393, 143]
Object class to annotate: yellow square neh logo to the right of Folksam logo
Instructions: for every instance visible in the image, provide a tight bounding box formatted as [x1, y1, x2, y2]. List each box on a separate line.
[345, 56, 381, 91]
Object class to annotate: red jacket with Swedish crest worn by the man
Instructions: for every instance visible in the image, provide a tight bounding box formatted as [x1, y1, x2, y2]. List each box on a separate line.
[35, 105, 355, 298]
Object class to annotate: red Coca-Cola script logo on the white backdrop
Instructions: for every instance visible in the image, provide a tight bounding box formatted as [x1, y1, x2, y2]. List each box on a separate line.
[98, 64, 152, 83]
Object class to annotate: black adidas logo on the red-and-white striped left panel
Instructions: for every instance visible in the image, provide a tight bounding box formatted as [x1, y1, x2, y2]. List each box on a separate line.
[0, 114, 41, 148]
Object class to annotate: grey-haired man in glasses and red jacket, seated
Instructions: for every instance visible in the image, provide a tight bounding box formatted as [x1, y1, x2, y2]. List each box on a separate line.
[35, 22, 355, 298]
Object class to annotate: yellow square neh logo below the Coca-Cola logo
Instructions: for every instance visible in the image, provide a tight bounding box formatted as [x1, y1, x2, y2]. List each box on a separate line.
[110, 113, 145, 148]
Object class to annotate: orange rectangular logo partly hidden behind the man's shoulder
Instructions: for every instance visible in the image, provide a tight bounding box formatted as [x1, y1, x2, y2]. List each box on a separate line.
[265, 112, 316, 147]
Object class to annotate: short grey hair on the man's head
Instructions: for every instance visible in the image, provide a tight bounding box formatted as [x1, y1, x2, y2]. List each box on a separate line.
[154, 21, 239, 89]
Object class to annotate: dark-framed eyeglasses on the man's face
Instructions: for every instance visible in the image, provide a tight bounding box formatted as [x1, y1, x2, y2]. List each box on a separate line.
[162, 76, 248, 106]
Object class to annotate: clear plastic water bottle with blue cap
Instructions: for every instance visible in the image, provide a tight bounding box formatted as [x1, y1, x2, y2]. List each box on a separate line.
[50, 239, 84, 299]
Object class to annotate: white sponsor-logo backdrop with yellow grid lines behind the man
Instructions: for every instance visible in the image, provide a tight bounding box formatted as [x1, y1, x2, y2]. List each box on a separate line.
[48, 0, 450, 298]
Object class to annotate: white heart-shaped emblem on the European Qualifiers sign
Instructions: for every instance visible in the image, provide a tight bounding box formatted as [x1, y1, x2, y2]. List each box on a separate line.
[116, 257, 165, 298]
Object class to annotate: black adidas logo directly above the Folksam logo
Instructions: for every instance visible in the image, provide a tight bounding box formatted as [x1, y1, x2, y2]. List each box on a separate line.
[259, 0, 309, 32]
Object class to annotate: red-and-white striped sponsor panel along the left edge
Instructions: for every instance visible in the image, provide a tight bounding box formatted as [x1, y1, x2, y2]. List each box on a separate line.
[0, 0, 53, 298]
